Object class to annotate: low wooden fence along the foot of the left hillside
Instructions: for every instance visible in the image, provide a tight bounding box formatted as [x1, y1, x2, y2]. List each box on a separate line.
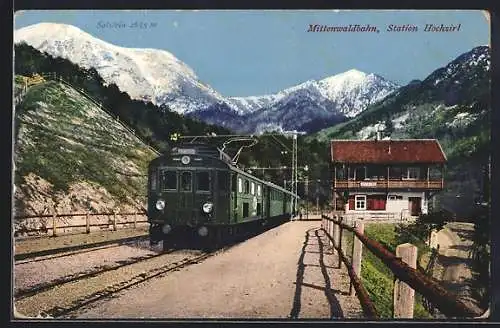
[14, 211, 148, 236]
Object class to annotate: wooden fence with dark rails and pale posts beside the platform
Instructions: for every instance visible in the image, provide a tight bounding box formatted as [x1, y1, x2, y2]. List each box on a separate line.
[321, 215, 482, 318]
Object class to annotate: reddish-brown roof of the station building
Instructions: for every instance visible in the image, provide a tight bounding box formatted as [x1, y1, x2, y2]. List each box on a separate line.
[331, 139, 446, 164]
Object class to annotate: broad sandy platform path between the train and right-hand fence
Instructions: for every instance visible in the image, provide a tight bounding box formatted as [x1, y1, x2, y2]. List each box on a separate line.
[68, 221, 362, 319]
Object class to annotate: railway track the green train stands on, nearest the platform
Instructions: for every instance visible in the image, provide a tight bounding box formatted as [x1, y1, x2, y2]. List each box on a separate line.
[14, 246, 223, 318]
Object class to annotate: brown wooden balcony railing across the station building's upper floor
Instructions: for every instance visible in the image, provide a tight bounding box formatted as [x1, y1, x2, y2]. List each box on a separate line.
[333, 180, 444, 189]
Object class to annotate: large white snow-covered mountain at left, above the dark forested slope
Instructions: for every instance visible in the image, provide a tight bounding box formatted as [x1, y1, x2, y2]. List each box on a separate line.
[14, 23, 225, 113]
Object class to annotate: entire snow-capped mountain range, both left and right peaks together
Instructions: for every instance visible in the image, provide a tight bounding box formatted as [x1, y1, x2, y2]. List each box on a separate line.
[14, 23, 398, 132]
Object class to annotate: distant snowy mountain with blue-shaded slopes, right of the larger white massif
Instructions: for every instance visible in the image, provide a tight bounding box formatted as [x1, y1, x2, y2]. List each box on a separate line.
[190, 69, 398, 133]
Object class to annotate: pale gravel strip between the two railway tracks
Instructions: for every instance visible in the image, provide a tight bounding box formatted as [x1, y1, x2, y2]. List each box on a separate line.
[14, 240, 158, 293]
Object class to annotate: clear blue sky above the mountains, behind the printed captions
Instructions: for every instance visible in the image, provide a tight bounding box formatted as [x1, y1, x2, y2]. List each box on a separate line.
[14, 10, 490, 96]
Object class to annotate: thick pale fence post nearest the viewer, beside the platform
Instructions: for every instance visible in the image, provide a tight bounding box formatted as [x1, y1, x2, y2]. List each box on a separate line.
[393, 243, 417, 319]
